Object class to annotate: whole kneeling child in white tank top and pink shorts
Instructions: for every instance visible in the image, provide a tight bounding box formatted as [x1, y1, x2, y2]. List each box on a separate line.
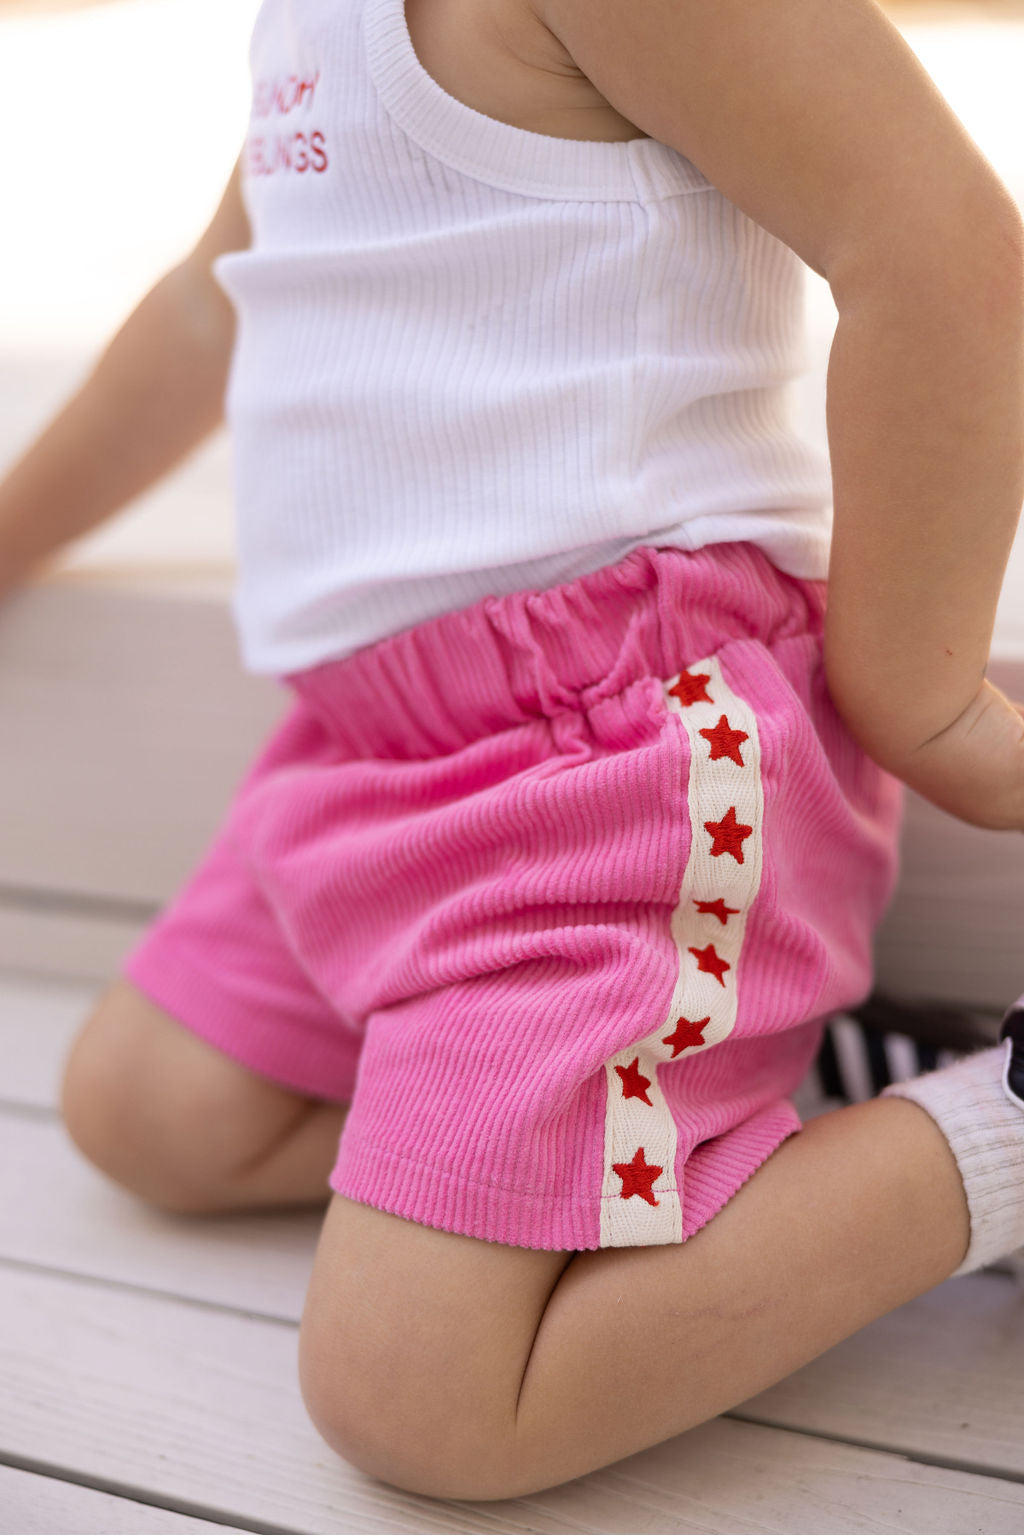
[0, 0, 1024, 1498]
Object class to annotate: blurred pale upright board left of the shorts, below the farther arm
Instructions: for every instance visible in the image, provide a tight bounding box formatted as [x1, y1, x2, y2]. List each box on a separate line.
[0, 583, 290, 906]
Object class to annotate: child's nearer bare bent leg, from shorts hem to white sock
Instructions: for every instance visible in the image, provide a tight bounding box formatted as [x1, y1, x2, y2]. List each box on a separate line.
[301, 1098, 969, 1498]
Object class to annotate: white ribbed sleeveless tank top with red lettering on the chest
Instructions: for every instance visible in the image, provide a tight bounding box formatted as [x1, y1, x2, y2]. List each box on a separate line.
[215, 0, 831, 675]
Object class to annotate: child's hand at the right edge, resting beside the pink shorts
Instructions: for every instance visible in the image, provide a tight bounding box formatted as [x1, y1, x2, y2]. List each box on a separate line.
[886, 682, 1024, 832]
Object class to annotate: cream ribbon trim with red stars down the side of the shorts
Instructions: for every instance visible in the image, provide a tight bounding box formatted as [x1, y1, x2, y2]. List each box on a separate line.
[600, 659, 765, 1246]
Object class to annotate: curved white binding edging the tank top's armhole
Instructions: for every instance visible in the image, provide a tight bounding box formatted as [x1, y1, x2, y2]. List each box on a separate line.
[364, 0, 711, 201]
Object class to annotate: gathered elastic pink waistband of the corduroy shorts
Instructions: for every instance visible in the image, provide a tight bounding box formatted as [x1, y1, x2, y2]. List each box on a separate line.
[279, 543, 826, 760]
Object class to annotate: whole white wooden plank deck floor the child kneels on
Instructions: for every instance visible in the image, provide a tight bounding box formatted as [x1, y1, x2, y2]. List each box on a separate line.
[0, 973, 1024, 1535]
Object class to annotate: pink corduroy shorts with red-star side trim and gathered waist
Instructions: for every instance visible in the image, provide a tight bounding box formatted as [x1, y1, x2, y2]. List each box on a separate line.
[123, 545, 900, 1251]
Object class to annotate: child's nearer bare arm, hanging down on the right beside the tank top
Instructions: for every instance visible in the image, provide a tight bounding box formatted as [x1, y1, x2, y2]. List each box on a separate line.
[534, 0, 1024, 829]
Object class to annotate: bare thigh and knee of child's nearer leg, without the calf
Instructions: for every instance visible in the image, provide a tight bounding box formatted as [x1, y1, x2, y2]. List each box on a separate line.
[299, 1194, 574, 1495]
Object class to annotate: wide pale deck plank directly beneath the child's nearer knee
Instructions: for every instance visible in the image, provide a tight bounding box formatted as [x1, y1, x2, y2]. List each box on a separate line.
[0, 1266, 1024, 1535]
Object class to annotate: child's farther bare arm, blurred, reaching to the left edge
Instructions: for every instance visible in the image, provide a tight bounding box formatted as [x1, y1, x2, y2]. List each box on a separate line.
[0, 154, 250, 599]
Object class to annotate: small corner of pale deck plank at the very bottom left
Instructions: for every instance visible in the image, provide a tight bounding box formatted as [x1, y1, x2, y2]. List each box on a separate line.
[0, 1466, 254, 1535]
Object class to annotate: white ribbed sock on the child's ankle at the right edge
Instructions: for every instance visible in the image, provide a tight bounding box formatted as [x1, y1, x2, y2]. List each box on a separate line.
[880, 1039, 1024, 1274]
